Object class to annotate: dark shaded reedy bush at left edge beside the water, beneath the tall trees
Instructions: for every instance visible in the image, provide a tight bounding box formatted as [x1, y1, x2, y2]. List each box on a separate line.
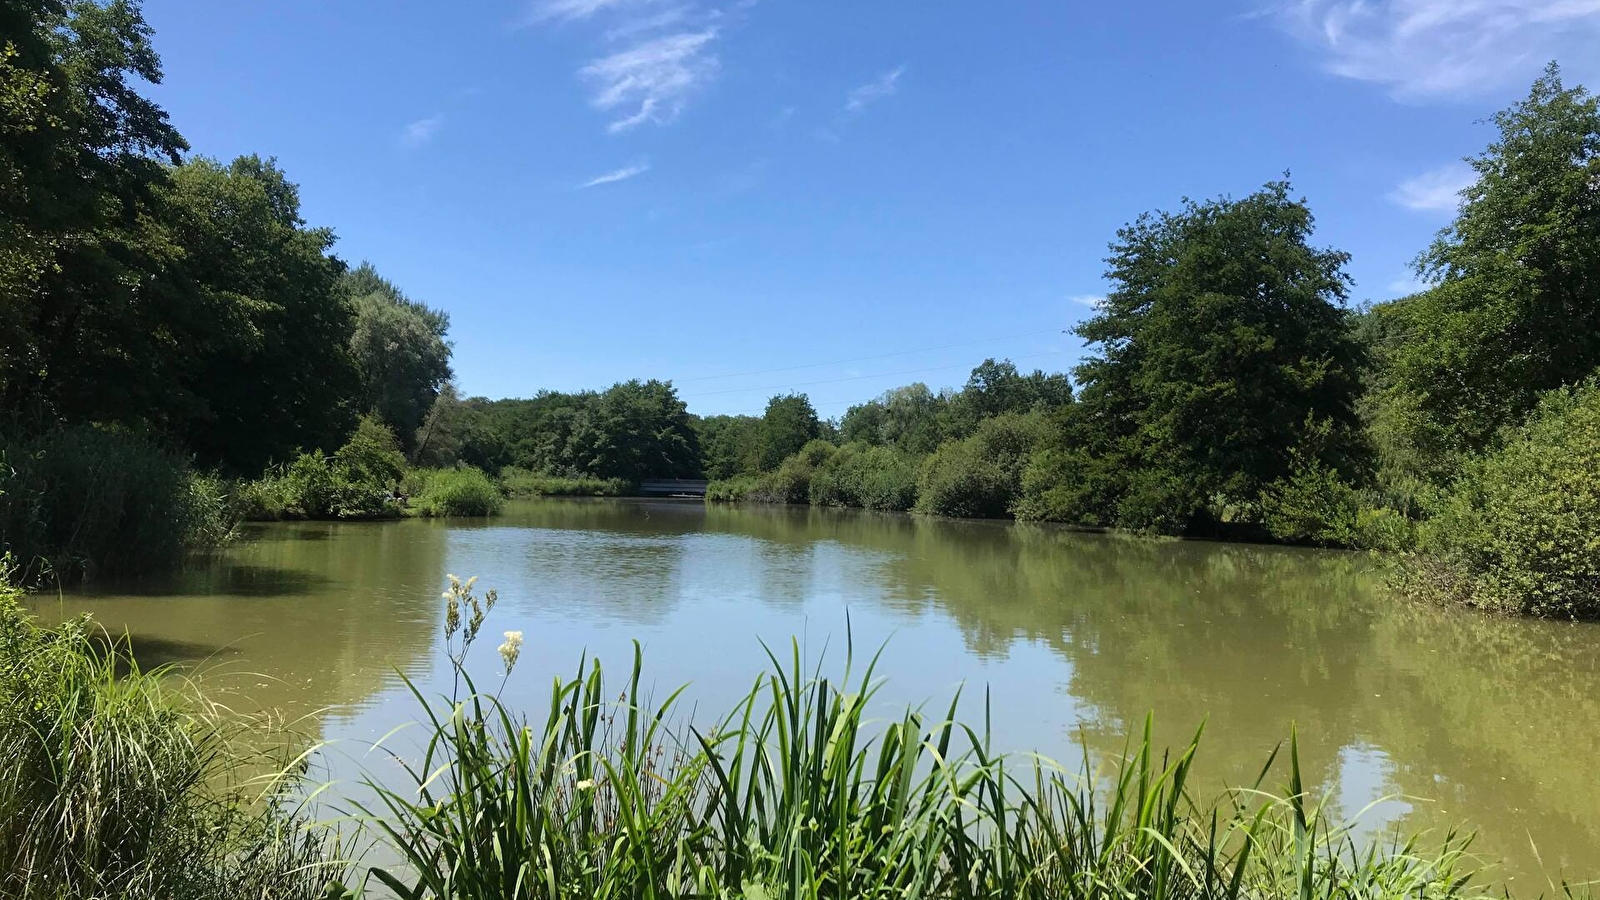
[0, 426, 235, 583]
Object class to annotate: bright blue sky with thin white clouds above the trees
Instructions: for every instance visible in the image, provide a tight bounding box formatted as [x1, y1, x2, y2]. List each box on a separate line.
[146, 0, 1600, 416]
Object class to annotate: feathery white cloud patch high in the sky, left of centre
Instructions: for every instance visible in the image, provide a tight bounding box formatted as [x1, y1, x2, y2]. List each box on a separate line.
[582, 29, 720, 133]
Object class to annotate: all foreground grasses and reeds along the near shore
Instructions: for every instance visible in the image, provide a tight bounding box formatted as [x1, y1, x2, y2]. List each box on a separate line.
[0, 570, 1586, 900]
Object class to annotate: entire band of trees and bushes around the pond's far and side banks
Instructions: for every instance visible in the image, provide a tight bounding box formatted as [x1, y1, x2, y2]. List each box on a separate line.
[0, 0, 1600, 615]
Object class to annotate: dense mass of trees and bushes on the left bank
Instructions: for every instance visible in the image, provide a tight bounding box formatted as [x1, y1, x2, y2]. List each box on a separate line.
[0, 0, 467, 581]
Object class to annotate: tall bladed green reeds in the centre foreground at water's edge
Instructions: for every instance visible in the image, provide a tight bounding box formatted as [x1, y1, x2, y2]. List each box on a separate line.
[344, 573, 1555, 900]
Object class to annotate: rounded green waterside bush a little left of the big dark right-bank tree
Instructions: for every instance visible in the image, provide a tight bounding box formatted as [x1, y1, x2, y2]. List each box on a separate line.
[917, 415, 1043, 519]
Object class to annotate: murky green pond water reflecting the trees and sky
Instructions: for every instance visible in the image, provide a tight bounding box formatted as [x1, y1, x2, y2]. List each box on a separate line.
[40, 501, 1600, 886]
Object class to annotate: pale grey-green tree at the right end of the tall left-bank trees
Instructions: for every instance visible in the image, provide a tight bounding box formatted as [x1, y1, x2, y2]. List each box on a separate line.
[342, 263, 453, 448]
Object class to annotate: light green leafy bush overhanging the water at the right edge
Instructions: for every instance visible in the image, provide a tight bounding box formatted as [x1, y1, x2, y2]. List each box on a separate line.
[1402, 381, 1600, 618]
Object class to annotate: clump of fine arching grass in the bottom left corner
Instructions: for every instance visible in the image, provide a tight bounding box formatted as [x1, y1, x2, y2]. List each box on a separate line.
[0, 581, 328, 900]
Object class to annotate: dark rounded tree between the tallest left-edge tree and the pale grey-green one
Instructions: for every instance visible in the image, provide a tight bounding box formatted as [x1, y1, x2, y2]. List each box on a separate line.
[160, 157, 358, 472]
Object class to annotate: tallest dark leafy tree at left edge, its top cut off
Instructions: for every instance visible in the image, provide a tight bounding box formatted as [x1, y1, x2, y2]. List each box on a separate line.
[0, 0, 187, 420]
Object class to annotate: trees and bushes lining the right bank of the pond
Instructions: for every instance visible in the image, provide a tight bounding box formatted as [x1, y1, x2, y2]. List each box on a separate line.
[694, 62, 1600, 617]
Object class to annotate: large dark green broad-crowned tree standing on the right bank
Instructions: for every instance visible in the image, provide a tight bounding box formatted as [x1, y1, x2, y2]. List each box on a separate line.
[1067, 181, 1362, 530]
